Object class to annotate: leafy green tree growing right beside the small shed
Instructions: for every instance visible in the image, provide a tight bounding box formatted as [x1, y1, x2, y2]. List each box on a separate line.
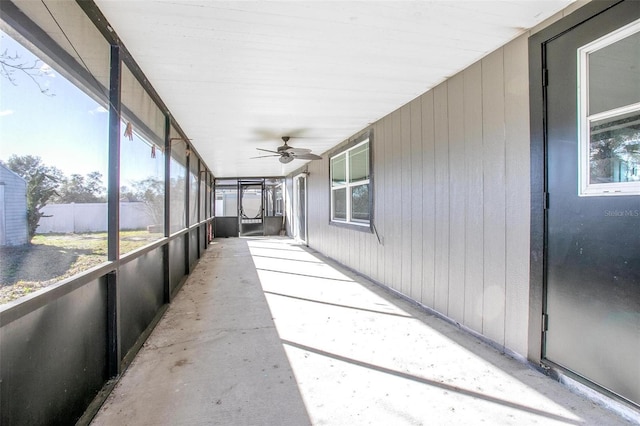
[6, 154, 63, 240]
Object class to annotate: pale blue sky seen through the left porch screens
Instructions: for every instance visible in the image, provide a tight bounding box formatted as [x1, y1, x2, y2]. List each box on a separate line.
[0, 27, 164, 185]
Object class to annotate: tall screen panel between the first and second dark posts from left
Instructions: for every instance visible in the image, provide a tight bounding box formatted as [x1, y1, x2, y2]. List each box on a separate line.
[120, 66, 165, 255]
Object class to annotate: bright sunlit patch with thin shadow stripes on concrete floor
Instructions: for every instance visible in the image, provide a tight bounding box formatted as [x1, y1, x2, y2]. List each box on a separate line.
[248, 239, 582, 425]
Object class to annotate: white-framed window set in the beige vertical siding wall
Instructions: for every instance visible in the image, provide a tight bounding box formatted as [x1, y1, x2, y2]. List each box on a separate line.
[330, 138, 371, 226]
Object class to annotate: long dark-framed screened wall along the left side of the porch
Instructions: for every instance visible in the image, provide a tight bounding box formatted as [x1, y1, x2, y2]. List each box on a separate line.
[0, 2, 214, 425]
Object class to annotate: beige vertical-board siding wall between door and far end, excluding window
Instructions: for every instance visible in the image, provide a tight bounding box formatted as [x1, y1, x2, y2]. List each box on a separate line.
[308, 36, 529, 355]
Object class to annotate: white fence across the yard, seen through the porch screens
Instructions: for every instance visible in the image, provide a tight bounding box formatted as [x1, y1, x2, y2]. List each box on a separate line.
[36, 202, 162, 234]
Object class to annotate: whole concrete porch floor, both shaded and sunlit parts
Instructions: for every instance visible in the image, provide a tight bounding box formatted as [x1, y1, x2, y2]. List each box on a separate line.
[92, 238, 640, 425]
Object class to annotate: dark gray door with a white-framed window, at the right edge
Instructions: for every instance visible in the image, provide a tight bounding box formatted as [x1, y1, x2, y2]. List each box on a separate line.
[543, 1, 640, 404]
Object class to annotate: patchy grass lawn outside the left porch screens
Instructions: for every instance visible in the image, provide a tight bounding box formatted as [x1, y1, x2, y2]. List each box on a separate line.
[0, 230, 162, 305]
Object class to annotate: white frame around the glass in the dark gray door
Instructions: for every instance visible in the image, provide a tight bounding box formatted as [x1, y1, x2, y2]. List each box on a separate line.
[577, 20, 640, 197]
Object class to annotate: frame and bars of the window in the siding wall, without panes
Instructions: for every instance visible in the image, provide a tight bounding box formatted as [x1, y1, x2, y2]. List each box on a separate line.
[328, 131, 374, 232]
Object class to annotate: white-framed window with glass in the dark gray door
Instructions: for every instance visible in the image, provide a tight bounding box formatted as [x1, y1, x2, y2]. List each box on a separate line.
[578, 21, 640, 196]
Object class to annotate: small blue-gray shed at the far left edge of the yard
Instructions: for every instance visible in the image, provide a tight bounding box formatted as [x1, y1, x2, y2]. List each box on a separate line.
[0, 163, 29, 247]
